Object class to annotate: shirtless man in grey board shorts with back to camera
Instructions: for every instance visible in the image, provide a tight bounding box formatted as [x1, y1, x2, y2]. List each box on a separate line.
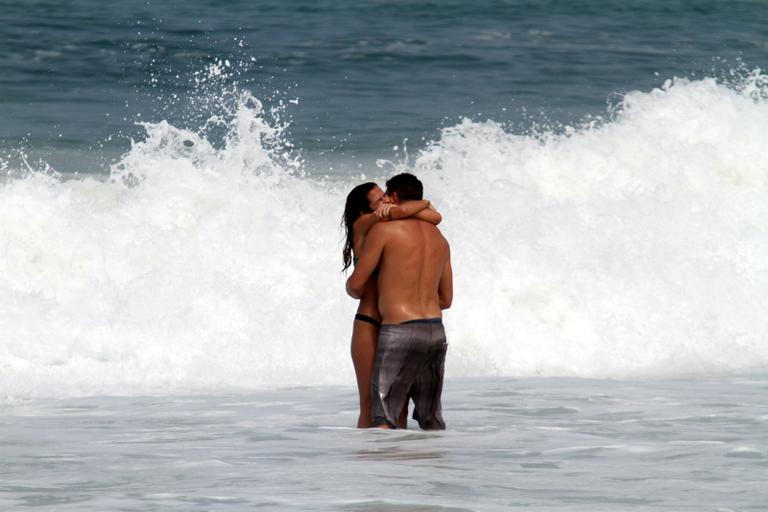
[347, 173, 453, 430]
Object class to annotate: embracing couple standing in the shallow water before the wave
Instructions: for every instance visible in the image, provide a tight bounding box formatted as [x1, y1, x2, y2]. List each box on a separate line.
[343, 173, 453, 430]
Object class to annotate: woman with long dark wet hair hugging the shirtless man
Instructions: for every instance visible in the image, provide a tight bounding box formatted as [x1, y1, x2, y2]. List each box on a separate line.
[342, 182, 442, 428]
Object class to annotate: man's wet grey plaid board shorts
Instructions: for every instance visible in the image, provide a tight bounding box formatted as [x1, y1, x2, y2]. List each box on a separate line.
[371, 318, 448, 430]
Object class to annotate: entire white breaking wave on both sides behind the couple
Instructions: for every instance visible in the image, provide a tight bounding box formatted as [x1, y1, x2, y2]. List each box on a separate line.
[0, 73, 768, 400]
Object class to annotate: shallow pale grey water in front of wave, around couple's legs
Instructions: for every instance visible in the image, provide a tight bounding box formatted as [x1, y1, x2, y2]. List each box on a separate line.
[0, 375, 768, 512]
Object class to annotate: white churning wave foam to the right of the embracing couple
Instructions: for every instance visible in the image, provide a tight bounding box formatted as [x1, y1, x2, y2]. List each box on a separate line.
[416, 73, 768, 377]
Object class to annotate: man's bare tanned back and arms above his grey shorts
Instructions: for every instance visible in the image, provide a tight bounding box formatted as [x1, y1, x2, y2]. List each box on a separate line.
[347, 219, 453, 324]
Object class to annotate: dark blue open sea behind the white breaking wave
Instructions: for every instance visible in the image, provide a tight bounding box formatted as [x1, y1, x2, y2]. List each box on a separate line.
[0, 0, 768, 172]
